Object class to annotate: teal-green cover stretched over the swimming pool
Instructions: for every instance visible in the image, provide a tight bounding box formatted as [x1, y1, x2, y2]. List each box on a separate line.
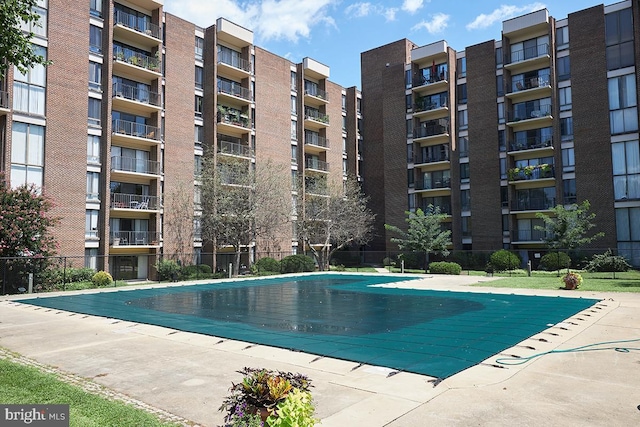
[20, 274, 598, 378]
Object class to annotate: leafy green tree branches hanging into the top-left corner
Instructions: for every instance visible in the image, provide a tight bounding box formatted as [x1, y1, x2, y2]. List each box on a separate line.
[0, 0, 50, 80]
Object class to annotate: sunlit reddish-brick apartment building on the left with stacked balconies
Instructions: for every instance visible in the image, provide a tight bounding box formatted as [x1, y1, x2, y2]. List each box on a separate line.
[0, 0, 361, 279]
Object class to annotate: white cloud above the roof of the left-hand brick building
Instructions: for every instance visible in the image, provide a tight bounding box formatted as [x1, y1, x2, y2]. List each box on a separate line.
[164, 0, 339, 42]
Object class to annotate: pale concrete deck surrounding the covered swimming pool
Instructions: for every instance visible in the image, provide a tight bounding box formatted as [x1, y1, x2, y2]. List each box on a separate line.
[0, 276, 640, 427]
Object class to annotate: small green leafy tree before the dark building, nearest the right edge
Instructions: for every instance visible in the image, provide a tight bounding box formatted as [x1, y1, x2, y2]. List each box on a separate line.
[535, 200, 604, 250]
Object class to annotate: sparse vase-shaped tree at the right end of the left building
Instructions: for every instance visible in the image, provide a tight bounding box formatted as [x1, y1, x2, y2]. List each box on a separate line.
[296, 178, 375, 271]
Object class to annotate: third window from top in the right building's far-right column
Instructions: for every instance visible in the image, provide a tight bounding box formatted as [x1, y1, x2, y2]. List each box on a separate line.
[611, 140, 640, 200]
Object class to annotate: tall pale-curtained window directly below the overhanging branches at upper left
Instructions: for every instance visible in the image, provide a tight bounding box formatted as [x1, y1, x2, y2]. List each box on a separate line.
[13, 45, 47, 116]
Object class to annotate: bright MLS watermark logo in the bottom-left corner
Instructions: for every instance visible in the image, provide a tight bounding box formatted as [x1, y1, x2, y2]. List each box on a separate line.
[0, 404, 69, 427]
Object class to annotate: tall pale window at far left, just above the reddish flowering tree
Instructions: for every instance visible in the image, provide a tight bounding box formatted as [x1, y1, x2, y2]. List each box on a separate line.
[11, 122, 44, 188]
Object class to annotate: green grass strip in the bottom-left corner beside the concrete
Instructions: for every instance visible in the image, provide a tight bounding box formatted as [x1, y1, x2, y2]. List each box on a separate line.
[0, 359, 179, 427]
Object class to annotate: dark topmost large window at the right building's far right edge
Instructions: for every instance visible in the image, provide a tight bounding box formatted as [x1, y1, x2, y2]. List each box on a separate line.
[605, 8, 634, 70]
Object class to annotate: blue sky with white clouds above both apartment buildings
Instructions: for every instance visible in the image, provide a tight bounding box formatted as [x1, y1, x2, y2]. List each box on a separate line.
[164, 0, 604, 87]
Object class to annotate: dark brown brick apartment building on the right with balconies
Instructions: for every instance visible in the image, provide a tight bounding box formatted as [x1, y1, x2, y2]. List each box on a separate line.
[362, 1, 640, 265]
